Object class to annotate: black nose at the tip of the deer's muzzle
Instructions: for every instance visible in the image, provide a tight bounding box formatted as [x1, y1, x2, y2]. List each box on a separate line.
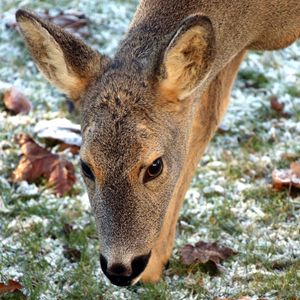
[100, 251, 151, 286]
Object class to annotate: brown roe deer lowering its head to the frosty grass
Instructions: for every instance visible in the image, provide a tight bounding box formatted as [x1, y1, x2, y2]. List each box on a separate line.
[16, 0, 300, 286]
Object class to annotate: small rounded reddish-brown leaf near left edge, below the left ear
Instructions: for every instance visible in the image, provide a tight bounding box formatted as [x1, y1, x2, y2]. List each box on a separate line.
[3, 88, 31, 114]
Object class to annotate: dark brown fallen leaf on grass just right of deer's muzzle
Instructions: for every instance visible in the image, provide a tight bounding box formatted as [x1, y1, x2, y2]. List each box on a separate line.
[180, 241, 236, 269]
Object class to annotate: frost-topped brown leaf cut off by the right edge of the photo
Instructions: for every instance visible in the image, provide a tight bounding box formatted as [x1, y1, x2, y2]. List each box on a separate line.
[272, 162, 300, 190]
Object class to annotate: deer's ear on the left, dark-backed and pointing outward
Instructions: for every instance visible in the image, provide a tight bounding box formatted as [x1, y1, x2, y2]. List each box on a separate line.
[16, 10, 108, 101]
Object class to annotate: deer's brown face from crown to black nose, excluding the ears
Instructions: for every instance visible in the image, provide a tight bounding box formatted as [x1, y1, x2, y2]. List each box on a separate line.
[80, 68, 191, 285]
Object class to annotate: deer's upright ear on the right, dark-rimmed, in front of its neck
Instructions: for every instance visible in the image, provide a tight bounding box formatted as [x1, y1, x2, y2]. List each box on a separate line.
[159, 15, 215, 100]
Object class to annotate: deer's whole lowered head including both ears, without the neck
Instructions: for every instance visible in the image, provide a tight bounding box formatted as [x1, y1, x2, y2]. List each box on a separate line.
[17, 10, 214, 285]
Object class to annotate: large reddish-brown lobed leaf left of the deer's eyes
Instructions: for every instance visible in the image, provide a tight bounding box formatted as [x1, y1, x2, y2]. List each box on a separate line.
[12, 134, 76, 196]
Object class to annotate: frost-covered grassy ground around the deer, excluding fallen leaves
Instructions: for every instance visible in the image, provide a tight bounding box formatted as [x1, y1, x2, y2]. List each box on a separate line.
[0, 0, 300, 300]
